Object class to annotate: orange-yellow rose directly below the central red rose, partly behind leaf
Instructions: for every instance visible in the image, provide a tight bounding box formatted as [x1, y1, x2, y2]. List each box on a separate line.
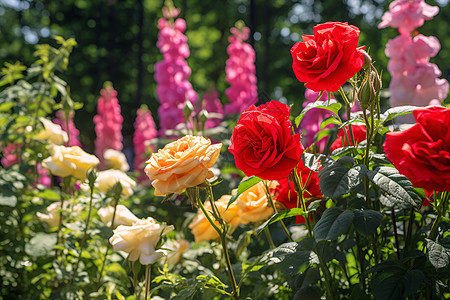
[236, 181, 278, 225]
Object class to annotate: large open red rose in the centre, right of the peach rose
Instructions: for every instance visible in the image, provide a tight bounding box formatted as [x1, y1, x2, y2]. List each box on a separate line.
[228, 100, 303, 180]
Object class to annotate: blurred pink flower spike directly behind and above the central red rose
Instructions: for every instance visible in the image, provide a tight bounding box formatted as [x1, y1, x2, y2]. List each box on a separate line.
[225, 27, 258, 115]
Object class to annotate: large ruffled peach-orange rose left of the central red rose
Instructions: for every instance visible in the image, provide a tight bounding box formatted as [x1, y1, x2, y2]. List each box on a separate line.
[145, 135, 222, 196]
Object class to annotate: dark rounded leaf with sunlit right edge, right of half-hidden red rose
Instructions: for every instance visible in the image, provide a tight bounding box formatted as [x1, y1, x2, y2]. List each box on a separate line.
[318, 156, 367, 199]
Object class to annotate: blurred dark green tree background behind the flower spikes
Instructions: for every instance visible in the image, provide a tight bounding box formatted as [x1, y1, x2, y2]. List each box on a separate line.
[0, 0, 450, 151]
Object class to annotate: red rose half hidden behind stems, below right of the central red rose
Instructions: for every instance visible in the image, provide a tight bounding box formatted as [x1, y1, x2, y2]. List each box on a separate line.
[274, 161, 323, 224]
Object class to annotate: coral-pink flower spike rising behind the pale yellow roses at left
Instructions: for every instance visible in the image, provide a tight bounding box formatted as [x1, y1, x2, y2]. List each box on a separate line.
[94, 84, 123, 166]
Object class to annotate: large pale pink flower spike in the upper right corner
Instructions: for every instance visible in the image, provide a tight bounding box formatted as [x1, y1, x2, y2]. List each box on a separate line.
[378, 0, 449, 106]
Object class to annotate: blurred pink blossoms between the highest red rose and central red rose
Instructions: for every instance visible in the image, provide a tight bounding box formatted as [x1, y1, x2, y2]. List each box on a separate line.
[296, 89, 333, 152]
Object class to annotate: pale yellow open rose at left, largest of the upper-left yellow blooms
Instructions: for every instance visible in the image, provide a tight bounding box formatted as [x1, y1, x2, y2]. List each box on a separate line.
[42, 145, 100, 180]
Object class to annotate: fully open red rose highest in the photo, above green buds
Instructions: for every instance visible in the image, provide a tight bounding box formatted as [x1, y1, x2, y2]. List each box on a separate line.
[291, 22, 364, 92]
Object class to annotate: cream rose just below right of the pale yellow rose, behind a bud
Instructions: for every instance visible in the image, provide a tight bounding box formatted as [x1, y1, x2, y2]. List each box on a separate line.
[95, 170, 136, 197]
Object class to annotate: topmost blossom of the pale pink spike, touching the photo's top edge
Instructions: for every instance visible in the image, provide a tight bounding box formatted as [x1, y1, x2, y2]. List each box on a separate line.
[378, 0, 439, 35]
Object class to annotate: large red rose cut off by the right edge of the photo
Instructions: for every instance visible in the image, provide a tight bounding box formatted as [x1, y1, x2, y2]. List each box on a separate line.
[384, 106, 450, 192]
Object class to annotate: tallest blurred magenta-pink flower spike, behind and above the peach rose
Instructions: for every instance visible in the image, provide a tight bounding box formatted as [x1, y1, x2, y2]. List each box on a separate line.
[155, 8, 198, 135]
